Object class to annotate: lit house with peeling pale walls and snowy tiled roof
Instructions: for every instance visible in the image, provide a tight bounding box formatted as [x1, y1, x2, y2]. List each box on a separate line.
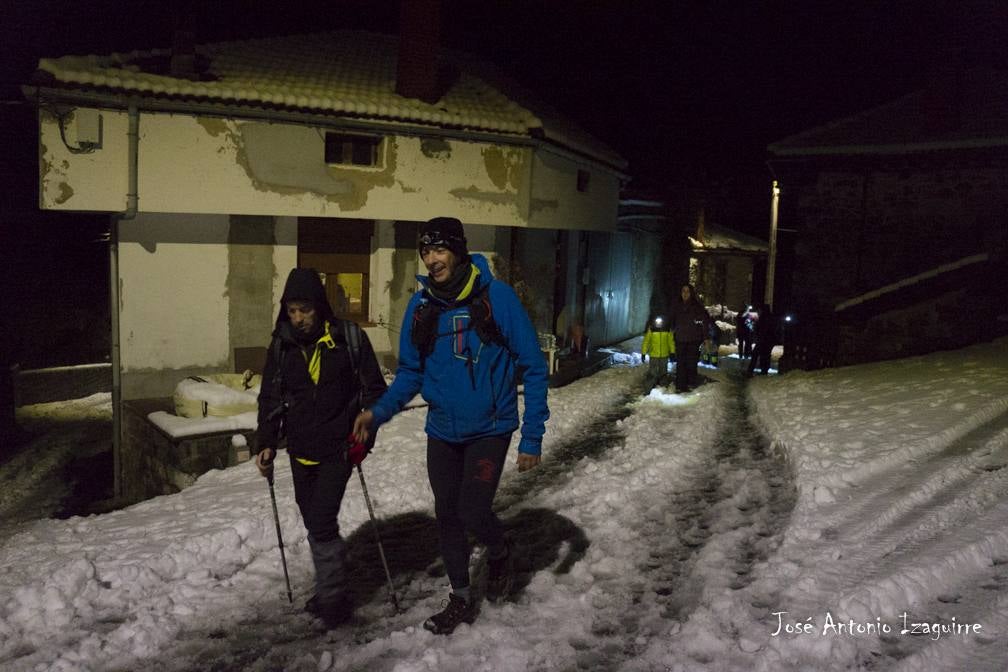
[24, 26, 660, 494]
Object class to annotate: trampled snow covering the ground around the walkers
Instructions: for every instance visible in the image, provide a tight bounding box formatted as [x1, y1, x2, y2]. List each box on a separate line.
[0, 340, 1008, 672]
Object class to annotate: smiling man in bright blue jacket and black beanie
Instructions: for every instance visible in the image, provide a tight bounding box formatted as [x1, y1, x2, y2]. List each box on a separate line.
[354, 217, 549, 635]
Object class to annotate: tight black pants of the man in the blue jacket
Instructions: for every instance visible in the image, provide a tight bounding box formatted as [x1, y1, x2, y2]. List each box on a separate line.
[427, 434, 511, 588]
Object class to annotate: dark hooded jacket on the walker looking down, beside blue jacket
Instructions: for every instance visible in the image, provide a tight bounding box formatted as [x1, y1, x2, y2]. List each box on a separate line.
[257, 268, 386, 461]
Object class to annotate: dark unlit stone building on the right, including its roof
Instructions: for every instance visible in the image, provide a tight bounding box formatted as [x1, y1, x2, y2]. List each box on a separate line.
[768, 68, 1008, 367]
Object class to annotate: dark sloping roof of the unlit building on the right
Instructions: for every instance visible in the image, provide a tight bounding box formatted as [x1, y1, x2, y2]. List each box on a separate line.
[767, 69, 1008, 156]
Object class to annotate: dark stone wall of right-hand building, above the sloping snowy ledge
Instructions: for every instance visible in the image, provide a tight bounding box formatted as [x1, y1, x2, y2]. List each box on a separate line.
[781, 163, 1008, 308]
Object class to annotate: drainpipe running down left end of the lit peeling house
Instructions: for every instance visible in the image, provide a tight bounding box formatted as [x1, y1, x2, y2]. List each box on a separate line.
[109, 103, 140, 497]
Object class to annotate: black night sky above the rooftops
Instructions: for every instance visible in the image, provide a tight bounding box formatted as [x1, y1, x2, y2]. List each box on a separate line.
[0, 0, 1008, 362]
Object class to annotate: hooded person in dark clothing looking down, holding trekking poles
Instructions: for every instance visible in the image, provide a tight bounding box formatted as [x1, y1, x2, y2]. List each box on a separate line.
[256, 268, 386, 628]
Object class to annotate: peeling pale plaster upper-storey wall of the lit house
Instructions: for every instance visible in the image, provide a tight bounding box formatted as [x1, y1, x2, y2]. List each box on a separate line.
[39, 105, 619, 230]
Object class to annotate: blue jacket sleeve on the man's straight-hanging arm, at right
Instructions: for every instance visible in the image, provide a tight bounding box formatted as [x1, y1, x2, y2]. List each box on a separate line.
[491, 281, 549, 455]
